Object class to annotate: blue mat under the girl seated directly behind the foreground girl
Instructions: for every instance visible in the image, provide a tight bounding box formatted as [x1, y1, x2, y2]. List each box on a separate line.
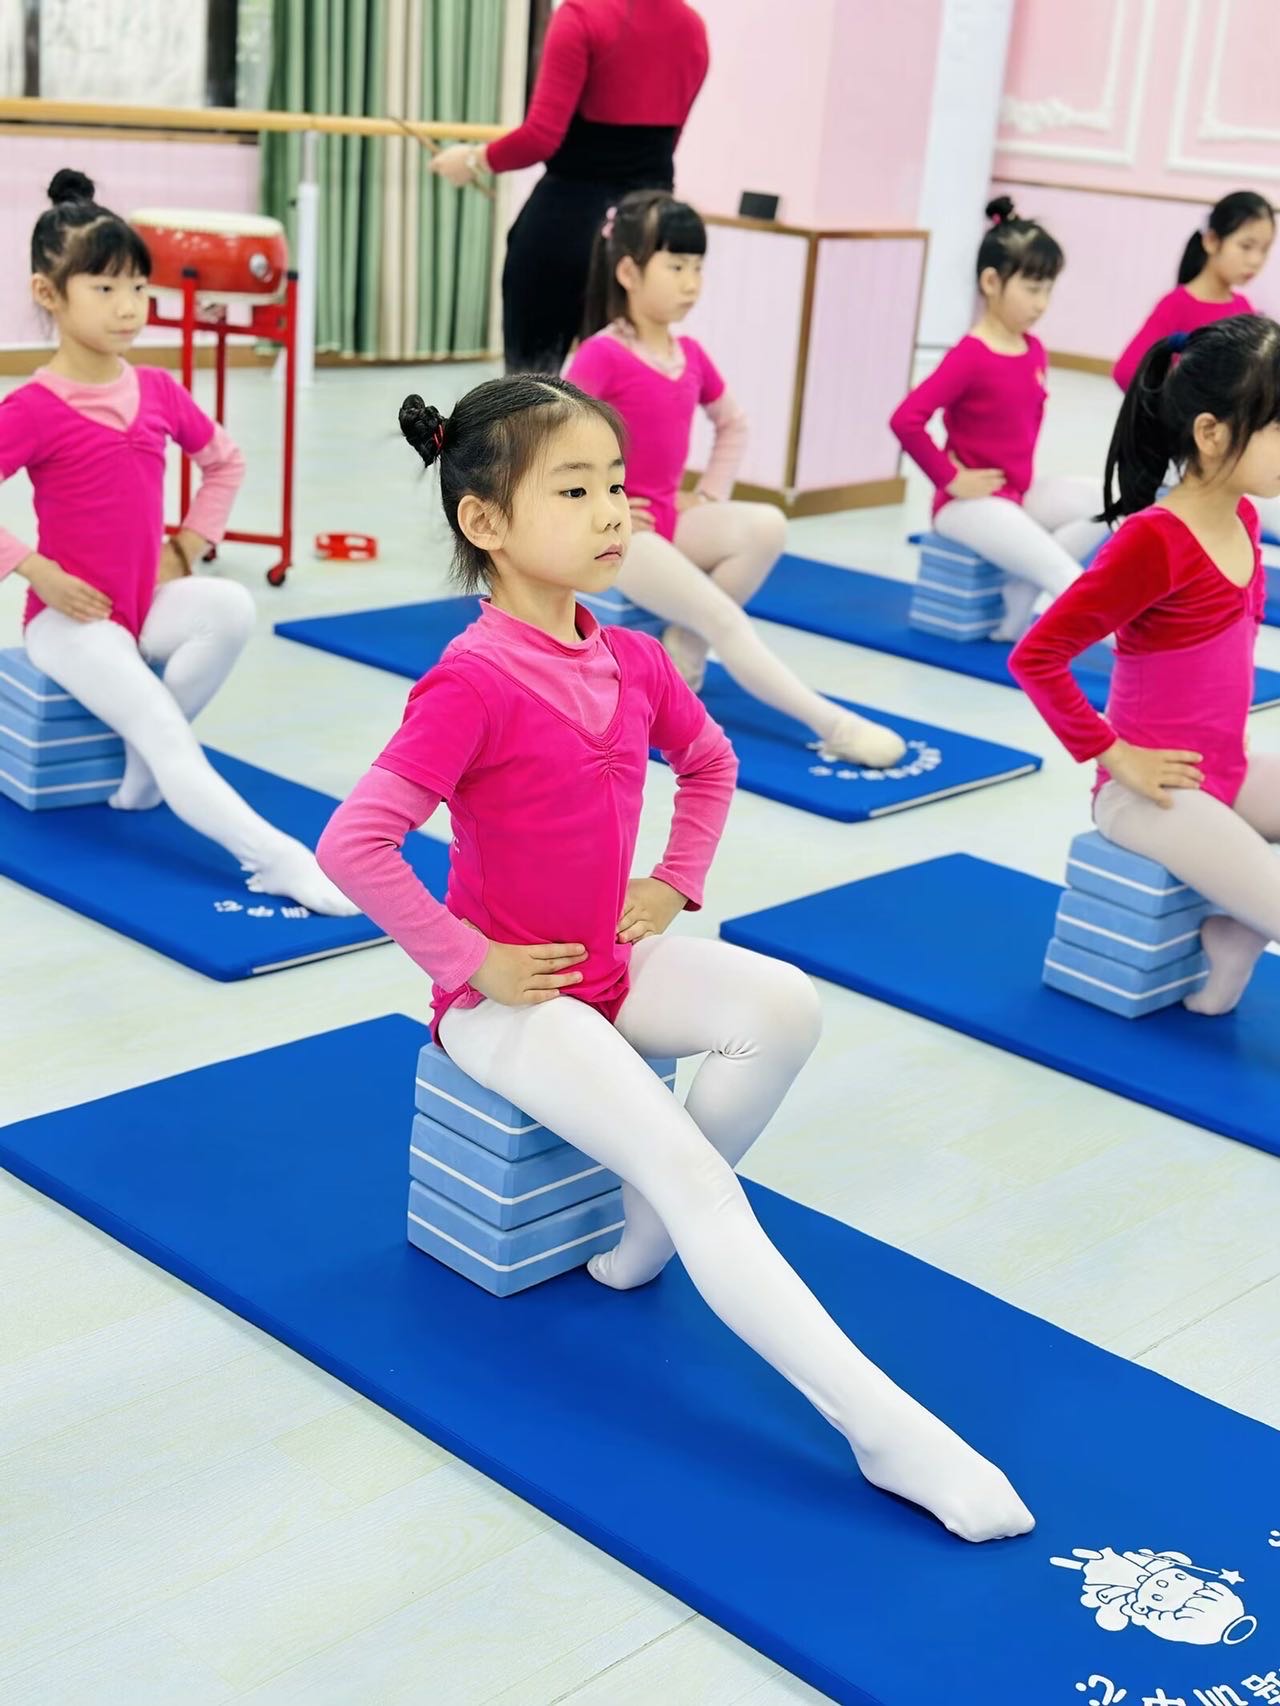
[275, 599, 1041, 824]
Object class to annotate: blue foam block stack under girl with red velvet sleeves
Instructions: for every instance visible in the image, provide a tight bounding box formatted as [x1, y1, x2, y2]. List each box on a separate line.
[1044, 829, 1210, 1018]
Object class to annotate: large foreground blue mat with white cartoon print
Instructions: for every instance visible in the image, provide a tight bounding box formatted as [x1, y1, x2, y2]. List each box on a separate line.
[0, 1017, 1280, 1706]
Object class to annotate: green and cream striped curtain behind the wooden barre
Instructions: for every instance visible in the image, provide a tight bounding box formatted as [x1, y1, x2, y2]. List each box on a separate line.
[261, 0, 505, 360]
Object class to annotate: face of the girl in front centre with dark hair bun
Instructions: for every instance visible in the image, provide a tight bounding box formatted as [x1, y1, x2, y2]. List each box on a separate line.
[471, 411, 631, 592]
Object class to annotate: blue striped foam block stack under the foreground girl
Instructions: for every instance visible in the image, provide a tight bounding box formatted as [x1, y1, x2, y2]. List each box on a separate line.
[408, 1042, 676, 1297]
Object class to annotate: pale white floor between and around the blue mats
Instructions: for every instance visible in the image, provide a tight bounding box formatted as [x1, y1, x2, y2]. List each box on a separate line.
[0, 353, 1280, 1706]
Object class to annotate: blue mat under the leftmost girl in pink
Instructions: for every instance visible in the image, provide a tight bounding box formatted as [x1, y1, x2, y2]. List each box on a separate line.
[0, 752, 449, 983]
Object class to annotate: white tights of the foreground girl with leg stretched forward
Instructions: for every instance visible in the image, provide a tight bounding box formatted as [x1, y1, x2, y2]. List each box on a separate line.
[440, 937, 1031, 1541]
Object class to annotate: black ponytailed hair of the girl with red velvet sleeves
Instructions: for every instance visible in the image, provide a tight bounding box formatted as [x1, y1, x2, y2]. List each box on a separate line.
[1103, 314, 1280, 525]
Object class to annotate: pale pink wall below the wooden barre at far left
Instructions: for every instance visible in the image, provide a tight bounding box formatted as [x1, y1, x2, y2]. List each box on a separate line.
[0, 136, 258, 350]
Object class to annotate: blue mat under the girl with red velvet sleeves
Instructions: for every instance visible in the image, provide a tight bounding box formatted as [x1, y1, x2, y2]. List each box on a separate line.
[720, 853, 1280, 1155]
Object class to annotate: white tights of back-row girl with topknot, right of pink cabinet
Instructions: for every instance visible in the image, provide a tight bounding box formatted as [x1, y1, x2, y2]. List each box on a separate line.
[934, 476, 1109, 640]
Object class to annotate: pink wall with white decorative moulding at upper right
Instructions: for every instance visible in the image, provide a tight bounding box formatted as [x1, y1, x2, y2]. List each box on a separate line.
[995, 0, 1280, 360]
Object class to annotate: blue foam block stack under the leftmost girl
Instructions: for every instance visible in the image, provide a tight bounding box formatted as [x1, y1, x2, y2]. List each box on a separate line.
[0, 647, 125, 812]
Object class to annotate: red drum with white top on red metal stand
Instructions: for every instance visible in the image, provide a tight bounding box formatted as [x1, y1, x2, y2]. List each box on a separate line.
[130, 208, 288, 302]
